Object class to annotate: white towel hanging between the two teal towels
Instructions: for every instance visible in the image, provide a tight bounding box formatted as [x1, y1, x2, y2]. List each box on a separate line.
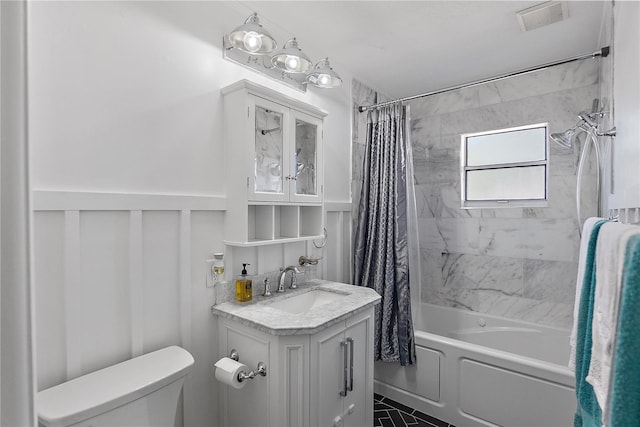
[586, 222, 640, 414]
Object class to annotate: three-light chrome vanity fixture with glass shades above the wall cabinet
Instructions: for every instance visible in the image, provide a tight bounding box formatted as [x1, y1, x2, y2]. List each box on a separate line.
[223, 13, 342, 92]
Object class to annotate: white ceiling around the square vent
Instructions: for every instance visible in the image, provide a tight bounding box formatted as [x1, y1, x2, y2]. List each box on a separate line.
[237, 1, 605, 99]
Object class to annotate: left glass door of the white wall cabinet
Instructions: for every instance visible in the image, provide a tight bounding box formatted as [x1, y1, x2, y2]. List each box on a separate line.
[250, 100, 289, 200]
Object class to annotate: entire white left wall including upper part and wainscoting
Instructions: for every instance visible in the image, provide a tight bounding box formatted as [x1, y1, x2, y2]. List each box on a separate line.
[28, 2, 351, 426]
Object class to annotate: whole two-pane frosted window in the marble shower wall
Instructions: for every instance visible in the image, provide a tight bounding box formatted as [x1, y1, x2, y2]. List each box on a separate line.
[460, 123, 549, 208]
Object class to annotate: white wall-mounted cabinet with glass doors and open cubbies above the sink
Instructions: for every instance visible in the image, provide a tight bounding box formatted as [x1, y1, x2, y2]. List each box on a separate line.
[222, 80, 326, 246]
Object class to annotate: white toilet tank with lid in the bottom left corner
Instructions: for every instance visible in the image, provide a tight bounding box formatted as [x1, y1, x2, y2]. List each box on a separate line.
[36, 346, 194, 427]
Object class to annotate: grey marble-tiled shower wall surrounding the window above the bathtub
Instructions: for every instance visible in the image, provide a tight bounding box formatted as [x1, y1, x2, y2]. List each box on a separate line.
[408, 61, 599, 327]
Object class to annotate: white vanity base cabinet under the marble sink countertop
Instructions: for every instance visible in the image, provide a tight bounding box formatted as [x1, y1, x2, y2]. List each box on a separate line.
[219, 307, 373, 427]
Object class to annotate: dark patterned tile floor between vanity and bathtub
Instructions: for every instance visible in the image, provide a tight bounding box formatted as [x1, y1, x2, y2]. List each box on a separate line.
[373, 393, 455, 427]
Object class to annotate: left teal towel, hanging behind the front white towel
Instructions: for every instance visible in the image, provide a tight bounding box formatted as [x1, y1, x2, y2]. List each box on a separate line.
[573, 221, 607, 427]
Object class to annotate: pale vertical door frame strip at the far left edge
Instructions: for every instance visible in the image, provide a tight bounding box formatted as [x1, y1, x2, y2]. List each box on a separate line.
[0, 1, 35, 426]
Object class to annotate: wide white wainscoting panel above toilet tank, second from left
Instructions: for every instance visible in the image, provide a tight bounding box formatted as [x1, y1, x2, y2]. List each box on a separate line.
[78, 211, 131, 377]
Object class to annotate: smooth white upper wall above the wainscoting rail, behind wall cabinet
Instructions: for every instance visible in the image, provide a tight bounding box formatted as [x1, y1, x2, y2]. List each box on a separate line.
[29, 2, 350, 200]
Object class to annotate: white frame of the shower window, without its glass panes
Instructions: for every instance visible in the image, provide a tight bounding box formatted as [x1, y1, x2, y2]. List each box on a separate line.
[460, 123, 549, 209]
